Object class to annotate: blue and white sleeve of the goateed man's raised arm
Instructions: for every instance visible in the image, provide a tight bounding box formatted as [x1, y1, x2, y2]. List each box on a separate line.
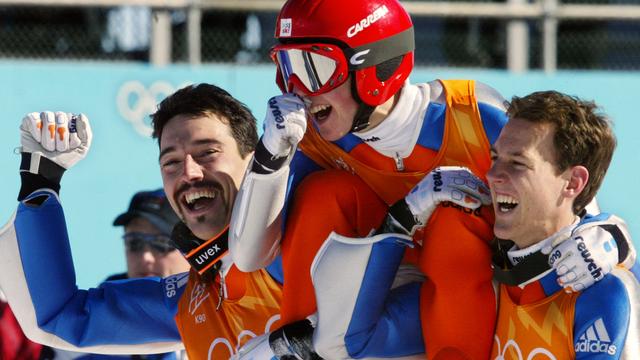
[0, 190, 188, 354]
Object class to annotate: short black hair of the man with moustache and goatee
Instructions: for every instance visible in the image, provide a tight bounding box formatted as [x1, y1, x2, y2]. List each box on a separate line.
[151, 83, 258, 158]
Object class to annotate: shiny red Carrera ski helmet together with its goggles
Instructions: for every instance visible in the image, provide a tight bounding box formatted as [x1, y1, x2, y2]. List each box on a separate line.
[271, 0, 415, 106]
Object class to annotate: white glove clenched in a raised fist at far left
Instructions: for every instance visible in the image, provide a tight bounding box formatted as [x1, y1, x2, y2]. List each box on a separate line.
[20, 111, 92, 173]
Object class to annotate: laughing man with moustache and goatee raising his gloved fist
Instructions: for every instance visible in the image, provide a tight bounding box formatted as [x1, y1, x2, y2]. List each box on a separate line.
[0, 84, 281, 359]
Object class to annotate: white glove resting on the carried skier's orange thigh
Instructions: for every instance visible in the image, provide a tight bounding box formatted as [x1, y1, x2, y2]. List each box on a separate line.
[404, 166, 491, 226]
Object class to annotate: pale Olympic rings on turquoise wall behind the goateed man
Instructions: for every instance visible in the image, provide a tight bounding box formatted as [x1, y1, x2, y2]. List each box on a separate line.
[116, 80, 191, 137]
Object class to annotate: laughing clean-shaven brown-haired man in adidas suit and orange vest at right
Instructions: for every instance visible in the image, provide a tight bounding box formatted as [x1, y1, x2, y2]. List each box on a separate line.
[487, 91, 640, 359]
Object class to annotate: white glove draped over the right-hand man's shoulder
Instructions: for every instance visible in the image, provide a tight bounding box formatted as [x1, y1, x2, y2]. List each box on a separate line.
[541, 222, 618, 292]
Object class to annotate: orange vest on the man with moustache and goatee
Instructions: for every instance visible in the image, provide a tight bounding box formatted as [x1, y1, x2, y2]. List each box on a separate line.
[176, 265, 282, 360]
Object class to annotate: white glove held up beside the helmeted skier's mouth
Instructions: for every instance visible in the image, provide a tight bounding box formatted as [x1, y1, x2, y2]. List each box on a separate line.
[262, 94, 307, 158]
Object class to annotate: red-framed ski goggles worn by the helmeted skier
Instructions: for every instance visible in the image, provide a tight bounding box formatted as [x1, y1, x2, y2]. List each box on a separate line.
[270, 44, 348, 95]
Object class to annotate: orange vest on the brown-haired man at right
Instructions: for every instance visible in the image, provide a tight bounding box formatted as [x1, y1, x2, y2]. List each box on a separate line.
[491, 285, 578, 360]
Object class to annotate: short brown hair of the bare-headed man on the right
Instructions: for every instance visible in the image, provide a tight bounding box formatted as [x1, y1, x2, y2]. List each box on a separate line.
[507, 91, 616, 214]
